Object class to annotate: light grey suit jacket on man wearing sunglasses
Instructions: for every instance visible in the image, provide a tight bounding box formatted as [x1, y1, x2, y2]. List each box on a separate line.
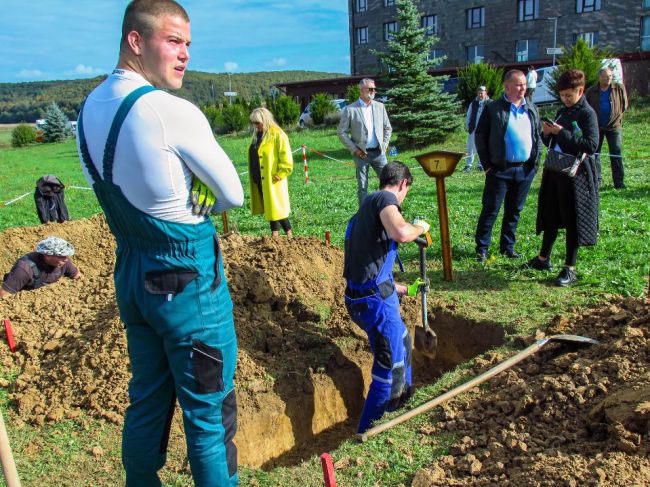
[337, 100, 393, 154]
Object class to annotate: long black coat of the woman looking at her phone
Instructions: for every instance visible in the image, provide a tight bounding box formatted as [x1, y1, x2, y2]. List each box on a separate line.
[537, 96, 600, 246]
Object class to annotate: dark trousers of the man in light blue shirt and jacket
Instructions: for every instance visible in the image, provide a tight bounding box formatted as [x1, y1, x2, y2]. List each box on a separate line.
[475, 165, 535, 254]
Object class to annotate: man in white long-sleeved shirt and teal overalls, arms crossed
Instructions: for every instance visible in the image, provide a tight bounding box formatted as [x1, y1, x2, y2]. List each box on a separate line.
[77, 0, 243, 487]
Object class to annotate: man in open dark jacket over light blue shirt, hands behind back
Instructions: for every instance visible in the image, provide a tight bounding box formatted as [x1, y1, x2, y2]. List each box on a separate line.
[475, 69, 540, 263]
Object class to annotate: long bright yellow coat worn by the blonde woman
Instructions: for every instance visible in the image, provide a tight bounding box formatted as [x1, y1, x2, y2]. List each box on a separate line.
[248, 126, 293, 221]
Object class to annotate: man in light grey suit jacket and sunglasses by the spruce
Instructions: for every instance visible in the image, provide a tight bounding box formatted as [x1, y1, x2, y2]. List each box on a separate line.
[338, 78, 393, 206]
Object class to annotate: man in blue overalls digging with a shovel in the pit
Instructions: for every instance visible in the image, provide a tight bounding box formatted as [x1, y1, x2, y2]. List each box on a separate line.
[343, 161, 429, 433]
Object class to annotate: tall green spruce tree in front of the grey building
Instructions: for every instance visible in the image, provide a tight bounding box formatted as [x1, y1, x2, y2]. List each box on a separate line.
[374, 0, 462, 149]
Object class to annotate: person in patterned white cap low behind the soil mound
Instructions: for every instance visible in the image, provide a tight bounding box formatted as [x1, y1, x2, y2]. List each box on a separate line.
[0, 236, 81, 298]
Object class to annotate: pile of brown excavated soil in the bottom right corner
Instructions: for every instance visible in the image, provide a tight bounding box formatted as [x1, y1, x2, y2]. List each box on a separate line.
[412, 299, 650, 487]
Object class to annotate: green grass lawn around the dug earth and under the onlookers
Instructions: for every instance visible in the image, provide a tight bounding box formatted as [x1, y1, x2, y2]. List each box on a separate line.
[0, 100, 650, 486]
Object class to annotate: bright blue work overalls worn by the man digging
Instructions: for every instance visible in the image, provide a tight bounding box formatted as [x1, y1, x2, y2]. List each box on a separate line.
[345, 217, 413, 433]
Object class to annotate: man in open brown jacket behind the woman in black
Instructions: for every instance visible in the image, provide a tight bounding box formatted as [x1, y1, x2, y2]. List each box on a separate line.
[586, 68, 628, 189]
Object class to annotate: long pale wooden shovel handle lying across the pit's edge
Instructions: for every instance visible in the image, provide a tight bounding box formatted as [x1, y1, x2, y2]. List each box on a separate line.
[357, 338, 550, 441]
